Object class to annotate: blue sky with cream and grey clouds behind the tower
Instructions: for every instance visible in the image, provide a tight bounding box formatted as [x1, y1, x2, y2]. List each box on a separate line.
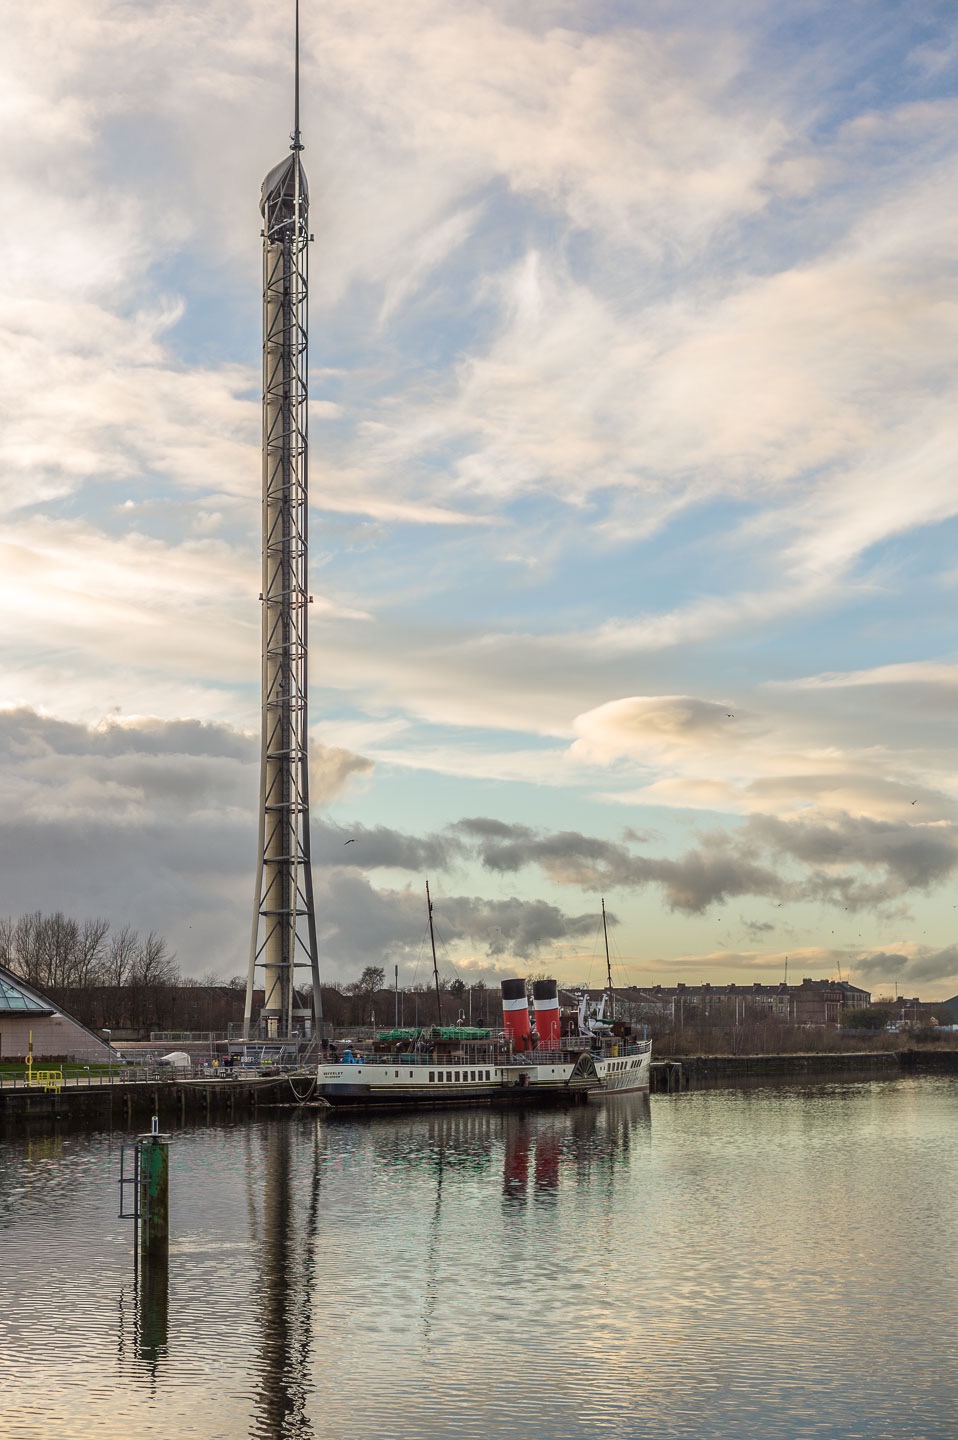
[0, 0, 958, 998]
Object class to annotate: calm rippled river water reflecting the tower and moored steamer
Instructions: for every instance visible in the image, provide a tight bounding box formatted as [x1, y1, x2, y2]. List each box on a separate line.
[0, 1079, 958, 1440]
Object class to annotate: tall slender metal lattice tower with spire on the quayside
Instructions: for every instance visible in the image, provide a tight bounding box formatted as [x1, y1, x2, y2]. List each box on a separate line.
[243, 0, 321, 1040]
